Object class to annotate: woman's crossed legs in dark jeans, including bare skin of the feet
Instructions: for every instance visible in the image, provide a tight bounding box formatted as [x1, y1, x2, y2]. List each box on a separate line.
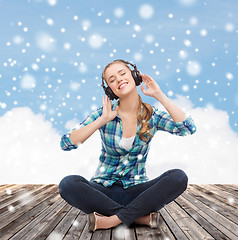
[59, 169, 188, 229]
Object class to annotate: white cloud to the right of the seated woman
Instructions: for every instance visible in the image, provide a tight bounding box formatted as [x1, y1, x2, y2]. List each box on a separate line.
[151, 95, 238, 184]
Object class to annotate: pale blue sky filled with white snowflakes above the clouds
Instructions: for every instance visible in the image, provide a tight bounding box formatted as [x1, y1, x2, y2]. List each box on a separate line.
[0, 0, 238, 134]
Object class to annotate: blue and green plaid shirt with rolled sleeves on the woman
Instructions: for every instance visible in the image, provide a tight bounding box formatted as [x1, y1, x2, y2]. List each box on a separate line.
[60, 101, 196, 188]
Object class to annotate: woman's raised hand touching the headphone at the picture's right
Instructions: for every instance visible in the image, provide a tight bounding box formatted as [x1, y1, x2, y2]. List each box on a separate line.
[140, 73, 163, 98]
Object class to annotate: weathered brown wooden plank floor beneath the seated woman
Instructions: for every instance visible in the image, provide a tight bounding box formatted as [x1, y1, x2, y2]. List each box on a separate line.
[0, 184, 238, 240]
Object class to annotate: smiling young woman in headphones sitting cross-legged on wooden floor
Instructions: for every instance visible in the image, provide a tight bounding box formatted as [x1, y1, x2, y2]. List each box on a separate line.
[59, 60, 196, 231]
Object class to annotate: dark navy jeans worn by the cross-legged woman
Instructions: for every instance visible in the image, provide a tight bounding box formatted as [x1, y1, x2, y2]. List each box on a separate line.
[59, 169, 188, 227]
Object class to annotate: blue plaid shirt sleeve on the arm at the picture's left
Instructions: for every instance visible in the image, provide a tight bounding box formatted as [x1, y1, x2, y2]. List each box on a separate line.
[60, 107, 102, 151]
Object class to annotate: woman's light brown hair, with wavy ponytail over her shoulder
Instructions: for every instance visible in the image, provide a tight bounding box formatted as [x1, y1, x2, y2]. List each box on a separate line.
[102, 60, 153, 141]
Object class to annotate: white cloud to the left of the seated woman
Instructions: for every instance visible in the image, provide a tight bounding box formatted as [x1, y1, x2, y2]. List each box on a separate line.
[0, 107, 101, 184]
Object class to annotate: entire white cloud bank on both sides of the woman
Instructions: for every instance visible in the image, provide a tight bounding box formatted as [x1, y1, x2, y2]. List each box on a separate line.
[0, 95, 238, 184]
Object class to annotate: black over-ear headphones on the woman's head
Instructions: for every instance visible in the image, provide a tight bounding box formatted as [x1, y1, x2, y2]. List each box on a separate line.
[101, 59, 142, 100]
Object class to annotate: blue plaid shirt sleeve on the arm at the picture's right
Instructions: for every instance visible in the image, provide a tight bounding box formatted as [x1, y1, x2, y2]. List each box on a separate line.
[154, 108, 197, 136]
